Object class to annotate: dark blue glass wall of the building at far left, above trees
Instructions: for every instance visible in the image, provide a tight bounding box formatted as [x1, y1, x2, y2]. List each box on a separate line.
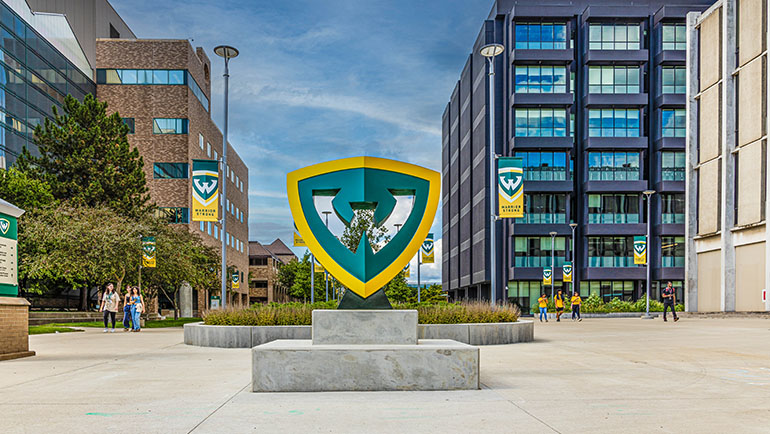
[0, 2, 96, 168]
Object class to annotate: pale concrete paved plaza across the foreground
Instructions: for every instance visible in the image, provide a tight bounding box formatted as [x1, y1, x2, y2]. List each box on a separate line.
[0, 317, 770, 433]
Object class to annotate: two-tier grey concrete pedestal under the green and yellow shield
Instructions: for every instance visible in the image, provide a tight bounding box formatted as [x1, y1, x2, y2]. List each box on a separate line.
[252, 310, 479, 392]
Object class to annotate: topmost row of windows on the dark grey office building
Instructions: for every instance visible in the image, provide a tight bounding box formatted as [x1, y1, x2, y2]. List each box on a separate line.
[514, 22, 687, 50]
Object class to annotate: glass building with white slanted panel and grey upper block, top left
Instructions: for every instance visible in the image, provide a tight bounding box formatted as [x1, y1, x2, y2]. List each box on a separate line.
[0, 0, 133, 168]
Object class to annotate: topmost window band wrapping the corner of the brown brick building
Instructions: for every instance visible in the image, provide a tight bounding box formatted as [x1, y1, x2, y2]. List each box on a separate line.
[96, 69, 209, 111]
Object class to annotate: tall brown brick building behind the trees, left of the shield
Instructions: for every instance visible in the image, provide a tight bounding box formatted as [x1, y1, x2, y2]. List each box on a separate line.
[96, 38, 249, 306]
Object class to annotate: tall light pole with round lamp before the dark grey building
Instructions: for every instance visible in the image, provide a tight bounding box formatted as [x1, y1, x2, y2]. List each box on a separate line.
[480, 44, 505, 305]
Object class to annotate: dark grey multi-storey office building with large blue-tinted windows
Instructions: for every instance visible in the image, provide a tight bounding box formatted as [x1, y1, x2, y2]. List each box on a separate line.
[442, 0, 711, 311]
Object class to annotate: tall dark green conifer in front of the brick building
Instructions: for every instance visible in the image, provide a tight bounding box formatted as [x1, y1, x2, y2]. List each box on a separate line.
[16, 95, 150, 217]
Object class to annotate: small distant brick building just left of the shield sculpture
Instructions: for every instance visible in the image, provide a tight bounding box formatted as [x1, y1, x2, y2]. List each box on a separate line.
[249, 239, 297, 304]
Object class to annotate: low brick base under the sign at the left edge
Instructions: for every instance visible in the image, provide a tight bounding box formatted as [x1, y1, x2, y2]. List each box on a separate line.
[0, 297, 35, 360]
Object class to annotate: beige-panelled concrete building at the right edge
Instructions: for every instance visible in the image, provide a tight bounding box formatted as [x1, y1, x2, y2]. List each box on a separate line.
[685, 0, 770, 312]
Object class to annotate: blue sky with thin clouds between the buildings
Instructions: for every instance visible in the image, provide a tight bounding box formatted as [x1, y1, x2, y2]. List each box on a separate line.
[110, 0, 493, 282]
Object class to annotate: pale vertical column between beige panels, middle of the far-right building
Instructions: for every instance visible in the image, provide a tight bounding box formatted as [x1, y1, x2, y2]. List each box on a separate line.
[720, 0, 738, 312]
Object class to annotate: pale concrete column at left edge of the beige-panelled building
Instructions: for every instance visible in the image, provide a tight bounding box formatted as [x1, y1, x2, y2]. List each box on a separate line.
[684, 12, 700, 312]
